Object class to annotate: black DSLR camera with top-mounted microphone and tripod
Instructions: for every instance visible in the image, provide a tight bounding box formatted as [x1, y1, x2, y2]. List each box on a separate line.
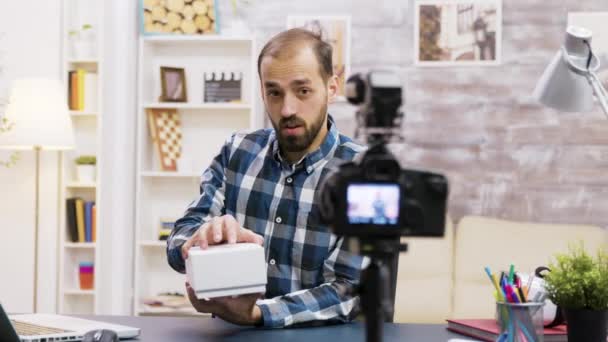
[320, 71, 448, 342]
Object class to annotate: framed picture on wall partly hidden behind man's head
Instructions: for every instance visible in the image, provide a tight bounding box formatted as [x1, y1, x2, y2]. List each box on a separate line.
[287, 15, 350, 100]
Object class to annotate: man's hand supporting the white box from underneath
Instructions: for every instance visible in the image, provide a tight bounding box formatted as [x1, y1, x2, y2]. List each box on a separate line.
[186, 283, 262, 325]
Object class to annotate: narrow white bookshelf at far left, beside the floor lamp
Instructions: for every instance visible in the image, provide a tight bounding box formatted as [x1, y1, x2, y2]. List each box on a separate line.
[57, 0, 103, 314]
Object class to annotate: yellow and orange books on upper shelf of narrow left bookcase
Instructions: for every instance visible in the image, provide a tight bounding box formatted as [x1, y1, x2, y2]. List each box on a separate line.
[68, 69, 97, 112]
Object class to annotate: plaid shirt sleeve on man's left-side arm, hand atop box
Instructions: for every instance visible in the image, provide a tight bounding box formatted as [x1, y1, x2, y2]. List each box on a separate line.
[167, 136, 234, 273]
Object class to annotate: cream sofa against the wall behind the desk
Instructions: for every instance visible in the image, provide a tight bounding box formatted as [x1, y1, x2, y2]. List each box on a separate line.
[394, 216, 608, 323]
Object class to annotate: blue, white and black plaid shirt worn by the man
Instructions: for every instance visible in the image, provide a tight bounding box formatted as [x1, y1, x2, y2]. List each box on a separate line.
[167, 116, 363, 327]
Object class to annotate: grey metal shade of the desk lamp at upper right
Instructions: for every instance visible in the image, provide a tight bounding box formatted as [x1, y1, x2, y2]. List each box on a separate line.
[534, 26, 599, 112]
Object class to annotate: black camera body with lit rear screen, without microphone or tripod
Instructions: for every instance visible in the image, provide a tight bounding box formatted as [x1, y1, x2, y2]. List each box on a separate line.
[321, 145, 448, 239]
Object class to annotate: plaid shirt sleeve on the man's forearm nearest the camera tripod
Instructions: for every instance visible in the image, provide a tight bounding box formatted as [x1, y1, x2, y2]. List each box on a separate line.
[256, 238, 367, 328]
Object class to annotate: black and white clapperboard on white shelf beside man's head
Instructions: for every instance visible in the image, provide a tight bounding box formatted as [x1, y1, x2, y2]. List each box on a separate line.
[204, 72, 243, 102]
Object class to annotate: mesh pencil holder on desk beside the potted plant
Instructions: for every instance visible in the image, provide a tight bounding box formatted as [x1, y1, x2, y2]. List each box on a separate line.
[496, 302, 545, 342]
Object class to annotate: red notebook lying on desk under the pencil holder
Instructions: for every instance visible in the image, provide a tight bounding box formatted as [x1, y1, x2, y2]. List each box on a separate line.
[447, 319, 568, 342]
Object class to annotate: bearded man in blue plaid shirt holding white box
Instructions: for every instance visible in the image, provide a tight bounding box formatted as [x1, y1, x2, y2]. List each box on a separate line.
[167, 29, 363, 327]
